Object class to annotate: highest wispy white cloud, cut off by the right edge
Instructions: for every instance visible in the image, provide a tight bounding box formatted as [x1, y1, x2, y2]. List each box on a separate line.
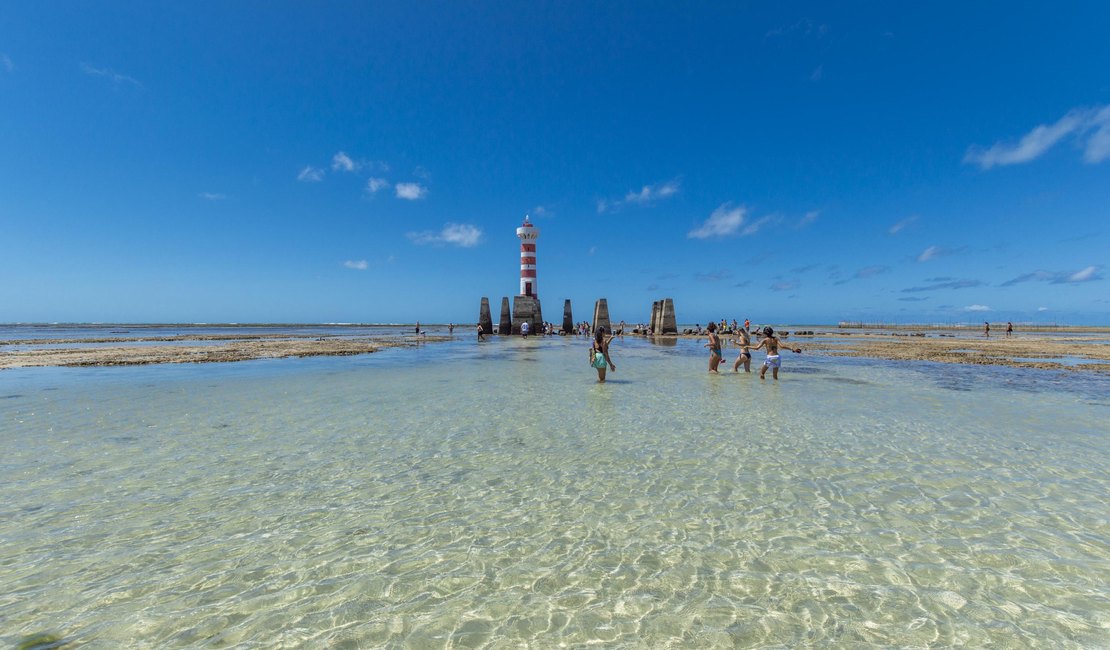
[963, 105, 1110, 170]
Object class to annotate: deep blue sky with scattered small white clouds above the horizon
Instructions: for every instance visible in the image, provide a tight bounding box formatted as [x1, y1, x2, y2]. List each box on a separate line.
[0, 1, 1110, 324]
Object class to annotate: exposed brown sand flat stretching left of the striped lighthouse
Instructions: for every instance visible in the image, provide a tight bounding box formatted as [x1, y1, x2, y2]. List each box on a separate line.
[0, 334, 448, 369]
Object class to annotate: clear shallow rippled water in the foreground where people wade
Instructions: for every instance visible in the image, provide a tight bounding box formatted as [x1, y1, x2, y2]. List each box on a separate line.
[0, 336, 1110, 648]
